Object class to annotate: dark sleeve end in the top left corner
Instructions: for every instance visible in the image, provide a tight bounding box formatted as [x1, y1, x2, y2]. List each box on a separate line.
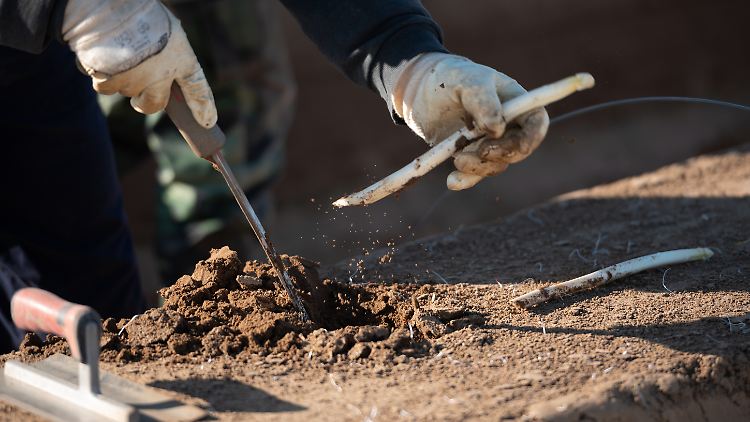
[0, 0, 67, 53]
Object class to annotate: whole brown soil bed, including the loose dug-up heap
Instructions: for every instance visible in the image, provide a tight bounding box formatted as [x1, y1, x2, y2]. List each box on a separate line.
[0, 145, 750, 421]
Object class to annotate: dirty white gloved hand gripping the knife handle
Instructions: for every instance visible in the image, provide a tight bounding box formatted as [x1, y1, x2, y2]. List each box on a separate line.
[62, 0, 216, 128]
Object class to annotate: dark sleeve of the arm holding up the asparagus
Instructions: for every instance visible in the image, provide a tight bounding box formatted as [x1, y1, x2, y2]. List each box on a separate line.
[282, 0, 447, 121]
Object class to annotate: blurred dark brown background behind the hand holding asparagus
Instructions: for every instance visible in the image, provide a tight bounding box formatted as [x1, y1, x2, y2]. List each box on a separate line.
[123, 0, 750, 296]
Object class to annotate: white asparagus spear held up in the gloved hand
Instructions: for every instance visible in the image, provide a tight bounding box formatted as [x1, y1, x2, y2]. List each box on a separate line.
[333, 73, 594, 208]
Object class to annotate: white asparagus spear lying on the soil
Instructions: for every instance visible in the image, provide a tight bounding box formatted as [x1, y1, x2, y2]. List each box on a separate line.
[510, 248, 714, 309]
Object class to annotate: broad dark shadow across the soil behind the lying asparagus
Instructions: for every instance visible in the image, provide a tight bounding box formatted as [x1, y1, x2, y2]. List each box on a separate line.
[346, 195, 750, 294]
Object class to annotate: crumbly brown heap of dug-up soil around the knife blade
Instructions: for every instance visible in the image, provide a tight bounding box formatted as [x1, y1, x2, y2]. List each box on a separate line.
[20, 247, 483, 363]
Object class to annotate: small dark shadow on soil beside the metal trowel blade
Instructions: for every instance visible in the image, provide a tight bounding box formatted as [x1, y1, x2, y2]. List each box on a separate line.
[149, 378, 305, 412]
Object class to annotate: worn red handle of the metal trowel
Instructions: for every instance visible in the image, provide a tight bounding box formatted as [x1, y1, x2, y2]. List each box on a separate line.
[10, 287, 101, 363]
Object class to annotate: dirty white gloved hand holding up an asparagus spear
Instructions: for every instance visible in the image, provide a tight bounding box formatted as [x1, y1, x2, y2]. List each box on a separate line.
[391, 53, 549, 188]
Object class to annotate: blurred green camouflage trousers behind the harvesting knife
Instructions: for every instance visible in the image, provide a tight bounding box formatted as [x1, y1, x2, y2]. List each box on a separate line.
[100, 0, 295, 277]
